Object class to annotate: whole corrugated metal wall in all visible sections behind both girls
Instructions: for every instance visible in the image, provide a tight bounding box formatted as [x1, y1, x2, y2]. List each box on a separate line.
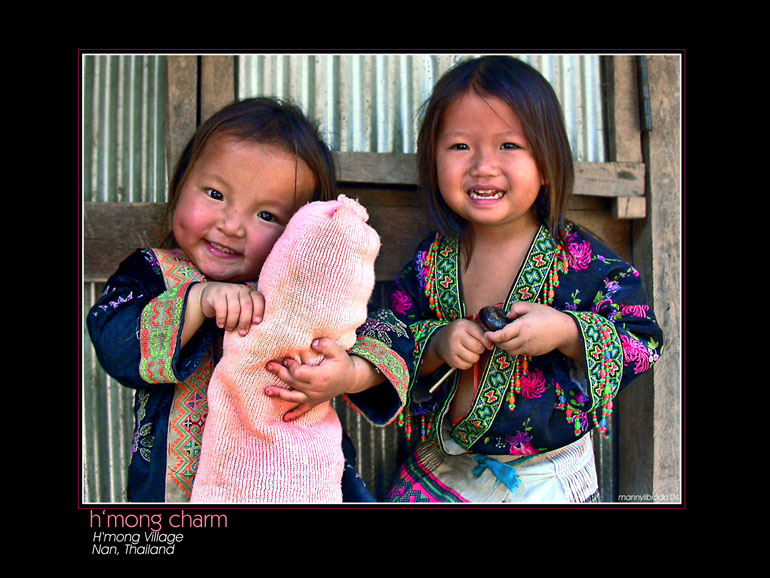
[82, 54, 605, 502]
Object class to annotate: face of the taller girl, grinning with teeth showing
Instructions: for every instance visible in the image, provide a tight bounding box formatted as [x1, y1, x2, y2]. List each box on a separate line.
[436, 91, 543, 234]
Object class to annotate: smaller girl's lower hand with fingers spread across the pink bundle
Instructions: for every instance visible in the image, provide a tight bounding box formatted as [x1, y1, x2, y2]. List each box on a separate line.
[265, 338, 383, 421]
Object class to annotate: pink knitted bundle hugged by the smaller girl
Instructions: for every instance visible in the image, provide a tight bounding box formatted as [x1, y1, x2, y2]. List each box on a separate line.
[191, 195, 380, 503]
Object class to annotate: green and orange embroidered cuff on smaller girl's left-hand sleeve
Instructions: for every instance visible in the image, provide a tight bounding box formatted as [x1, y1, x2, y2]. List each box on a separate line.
[139, 283, 190, 383]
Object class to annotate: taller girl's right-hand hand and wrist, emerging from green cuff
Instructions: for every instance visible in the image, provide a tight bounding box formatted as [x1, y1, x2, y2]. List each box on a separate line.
[485, 302, 582, 360]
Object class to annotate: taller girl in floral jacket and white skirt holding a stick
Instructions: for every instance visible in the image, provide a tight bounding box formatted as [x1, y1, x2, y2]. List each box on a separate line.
[389, 56, 662, 503]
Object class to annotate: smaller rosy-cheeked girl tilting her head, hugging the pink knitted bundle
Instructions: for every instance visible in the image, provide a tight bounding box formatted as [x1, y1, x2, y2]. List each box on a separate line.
[87, 98, 413, 502]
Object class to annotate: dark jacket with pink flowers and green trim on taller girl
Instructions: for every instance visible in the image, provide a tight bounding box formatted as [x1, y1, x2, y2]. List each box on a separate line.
[391, 226, 662, 455]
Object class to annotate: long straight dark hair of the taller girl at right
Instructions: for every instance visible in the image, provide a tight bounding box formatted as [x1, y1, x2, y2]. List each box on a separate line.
[417, 56, 574, 251]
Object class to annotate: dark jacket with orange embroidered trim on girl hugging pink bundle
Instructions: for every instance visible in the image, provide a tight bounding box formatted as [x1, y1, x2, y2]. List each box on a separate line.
[86, 249, 414, 502]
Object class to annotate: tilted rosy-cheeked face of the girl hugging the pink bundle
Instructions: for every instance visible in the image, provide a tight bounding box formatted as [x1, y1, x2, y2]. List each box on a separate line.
[172, 134, 315, 282]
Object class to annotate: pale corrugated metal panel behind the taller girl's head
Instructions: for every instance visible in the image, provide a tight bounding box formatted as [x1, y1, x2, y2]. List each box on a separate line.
[237, 54, 606, 162]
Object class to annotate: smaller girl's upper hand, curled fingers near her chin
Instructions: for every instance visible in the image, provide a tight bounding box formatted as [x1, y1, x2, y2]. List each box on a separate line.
[199, 282, 265, 335]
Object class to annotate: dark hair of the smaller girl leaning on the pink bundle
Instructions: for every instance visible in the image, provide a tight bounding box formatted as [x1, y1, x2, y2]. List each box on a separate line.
[163, 97, 337, 247]
